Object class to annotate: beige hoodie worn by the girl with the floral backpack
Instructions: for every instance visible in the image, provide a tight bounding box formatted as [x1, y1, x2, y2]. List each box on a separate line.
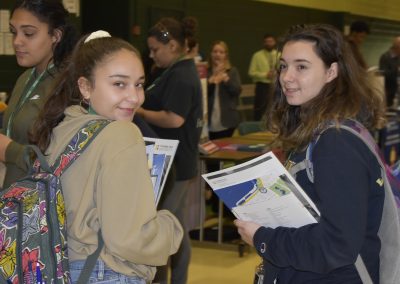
[46, 106, 183, 280]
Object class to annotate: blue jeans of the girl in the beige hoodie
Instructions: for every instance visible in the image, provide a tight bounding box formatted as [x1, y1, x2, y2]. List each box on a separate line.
[69, 259, 146, 284]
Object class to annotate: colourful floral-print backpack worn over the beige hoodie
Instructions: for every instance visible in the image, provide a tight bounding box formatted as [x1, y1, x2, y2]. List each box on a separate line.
[0, 120, 109, 284]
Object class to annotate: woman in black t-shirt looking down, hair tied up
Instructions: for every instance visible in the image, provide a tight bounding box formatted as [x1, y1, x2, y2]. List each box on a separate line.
[137, 18, 203, 284]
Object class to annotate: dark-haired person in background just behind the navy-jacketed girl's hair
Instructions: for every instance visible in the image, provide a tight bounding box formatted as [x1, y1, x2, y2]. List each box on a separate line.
[346, 21, 369, 69]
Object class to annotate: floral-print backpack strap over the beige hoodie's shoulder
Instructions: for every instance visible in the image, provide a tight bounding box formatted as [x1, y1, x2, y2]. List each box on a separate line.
[52, 119, 111, 176]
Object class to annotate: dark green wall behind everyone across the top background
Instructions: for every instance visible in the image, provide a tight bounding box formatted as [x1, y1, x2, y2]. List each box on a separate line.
[0, 0, 400, 91]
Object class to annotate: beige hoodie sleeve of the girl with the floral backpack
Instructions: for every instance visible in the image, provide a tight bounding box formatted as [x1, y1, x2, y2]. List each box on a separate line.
[96, 123, 183, 266]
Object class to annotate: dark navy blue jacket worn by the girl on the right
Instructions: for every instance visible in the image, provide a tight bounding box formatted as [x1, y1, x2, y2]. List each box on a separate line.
[253, 128, 384, 284]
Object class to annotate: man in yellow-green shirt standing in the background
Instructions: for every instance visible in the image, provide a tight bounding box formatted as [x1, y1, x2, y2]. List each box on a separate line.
[248, 34, 278, 120]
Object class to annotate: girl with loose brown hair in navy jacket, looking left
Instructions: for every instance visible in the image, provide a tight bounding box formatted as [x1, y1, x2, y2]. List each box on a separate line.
[235, 25, 385, 284]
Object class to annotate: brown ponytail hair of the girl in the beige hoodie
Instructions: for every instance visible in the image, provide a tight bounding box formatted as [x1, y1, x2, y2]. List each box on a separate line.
[30, 36, 140, 152]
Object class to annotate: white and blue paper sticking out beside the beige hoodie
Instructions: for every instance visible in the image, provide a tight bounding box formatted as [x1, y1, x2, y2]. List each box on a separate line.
[144, 137, 179, 204]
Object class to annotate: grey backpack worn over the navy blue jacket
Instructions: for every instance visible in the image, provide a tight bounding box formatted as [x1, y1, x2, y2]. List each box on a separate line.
[290, 120, 400, 284]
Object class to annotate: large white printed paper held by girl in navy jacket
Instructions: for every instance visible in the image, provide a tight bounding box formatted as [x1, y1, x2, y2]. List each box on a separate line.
[203, 152, 320, 228]
